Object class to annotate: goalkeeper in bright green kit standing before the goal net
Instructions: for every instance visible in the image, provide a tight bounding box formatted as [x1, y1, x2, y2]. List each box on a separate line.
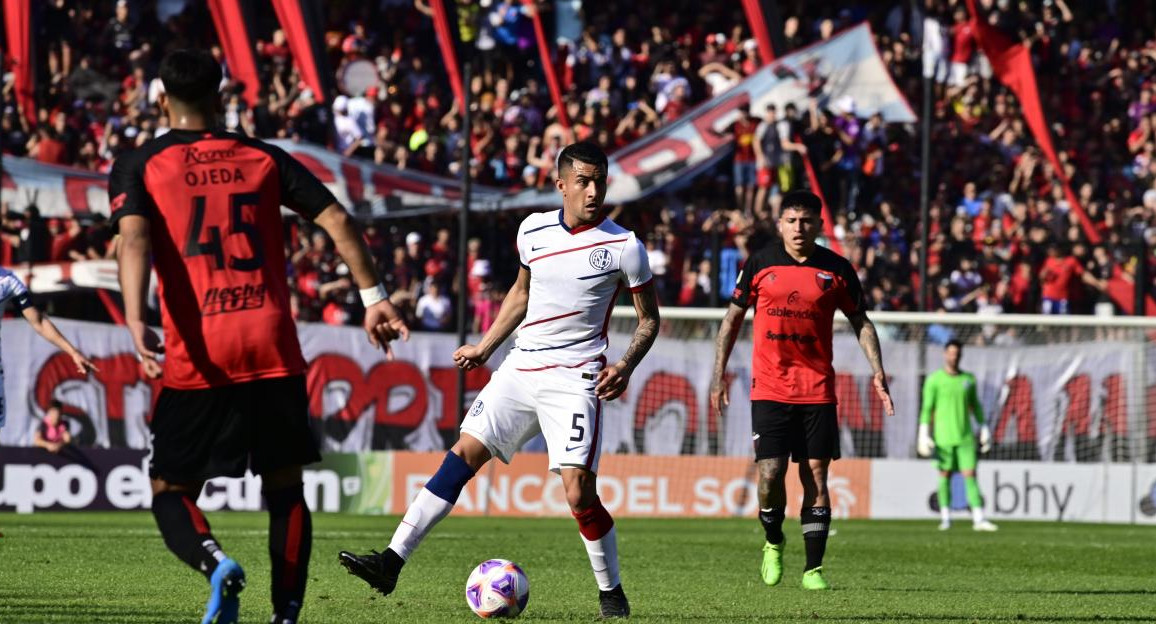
[916, 340, 999, 530]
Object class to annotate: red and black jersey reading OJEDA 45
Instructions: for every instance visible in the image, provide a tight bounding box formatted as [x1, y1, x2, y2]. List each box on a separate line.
[109, 129, 336, 388]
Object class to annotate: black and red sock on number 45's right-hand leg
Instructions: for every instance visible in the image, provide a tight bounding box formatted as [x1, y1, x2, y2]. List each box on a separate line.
[265, 483, 313, 614]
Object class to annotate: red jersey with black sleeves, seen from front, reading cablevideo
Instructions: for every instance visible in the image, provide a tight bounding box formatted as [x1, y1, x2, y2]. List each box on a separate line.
[731, 240, 867, 403]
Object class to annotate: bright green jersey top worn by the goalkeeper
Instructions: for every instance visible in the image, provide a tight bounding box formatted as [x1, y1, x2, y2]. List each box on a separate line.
[919, 369, 984, 446]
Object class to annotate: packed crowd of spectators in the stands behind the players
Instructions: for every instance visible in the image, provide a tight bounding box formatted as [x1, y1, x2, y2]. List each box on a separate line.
[0, 0, 1156, 329]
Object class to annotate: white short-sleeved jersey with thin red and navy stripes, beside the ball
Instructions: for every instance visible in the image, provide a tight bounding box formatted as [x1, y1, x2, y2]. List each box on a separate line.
[511, 209, 651, 366]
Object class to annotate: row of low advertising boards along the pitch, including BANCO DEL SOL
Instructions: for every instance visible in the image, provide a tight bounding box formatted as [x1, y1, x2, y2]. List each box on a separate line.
[0, 447, 1156, 522]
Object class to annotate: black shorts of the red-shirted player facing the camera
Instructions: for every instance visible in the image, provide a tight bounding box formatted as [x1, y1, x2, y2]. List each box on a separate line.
[750, 401, 839, 461]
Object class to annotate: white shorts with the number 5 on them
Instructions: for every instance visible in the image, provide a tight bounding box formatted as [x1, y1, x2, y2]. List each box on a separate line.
[461, 350, 603, 473]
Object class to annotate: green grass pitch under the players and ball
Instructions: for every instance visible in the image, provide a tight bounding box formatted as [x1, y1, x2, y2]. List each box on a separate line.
[0, 512, 1156, 624]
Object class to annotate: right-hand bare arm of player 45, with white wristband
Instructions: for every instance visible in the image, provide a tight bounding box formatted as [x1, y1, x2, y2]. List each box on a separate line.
[313, 203, 409, 358]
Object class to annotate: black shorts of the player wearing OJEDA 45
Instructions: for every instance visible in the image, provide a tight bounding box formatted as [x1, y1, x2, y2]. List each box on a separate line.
[149, 374, 321, 483]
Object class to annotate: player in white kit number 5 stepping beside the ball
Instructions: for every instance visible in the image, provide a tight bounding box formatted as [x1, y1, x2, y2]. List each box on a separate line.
[339, 142, 659, 617]
